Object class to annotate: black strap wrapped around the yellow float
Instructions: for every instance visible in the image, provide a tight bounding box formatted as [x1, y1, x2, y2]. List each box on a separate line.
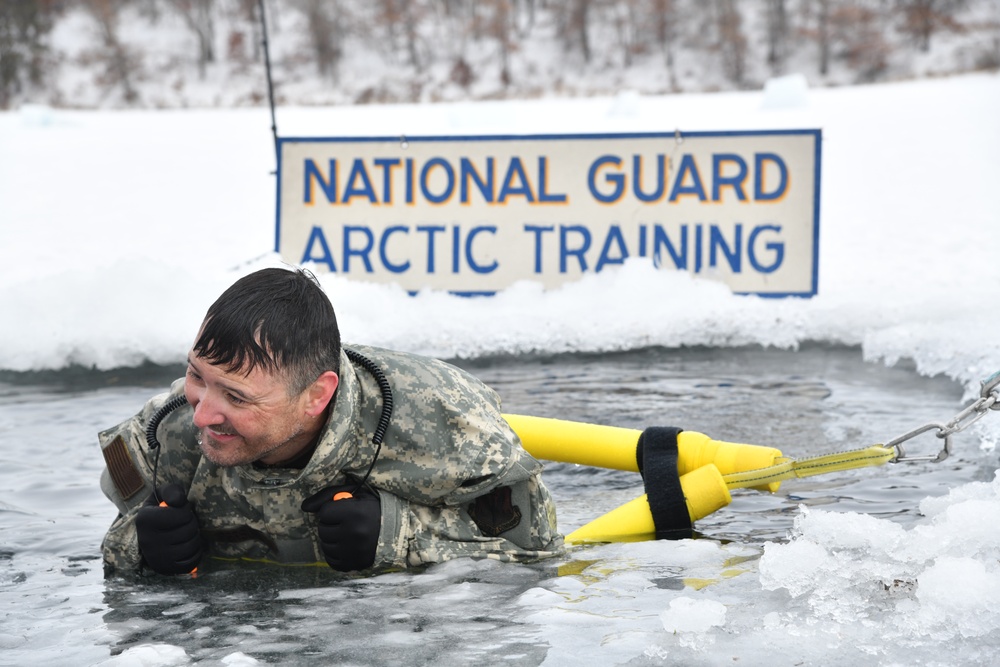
[635, 426, 691, 540]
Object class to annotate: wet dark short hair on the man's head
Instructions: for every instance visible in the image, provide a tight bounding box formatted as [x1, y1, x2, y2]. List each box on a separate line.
[194, 269, 340, 396]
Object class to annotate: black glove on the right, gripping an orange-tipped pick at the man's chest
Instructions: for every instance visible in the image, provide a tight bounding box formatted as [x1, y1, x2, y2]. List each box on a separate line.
[302, 484, 382, 572]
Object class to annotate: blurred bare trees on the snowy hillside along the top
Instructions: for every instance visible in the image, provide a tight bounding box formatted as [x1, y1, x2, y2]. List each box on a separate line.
[0, 0, 1000, 108]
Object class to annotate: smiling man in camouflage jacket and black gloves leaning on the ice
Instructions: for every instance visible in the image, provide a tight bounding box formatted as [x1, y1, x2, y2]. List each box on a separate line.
[100, 269, 562, 574]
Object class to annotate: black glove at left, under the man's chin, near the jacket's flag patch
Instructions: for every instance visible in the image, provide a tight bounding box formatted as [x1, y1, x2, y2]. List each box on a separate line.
[135, 484, 202, 574]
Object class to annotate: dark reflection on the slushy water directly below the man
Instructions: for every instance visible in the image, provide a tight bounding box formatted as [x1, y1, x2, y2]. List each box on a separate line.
[103, 562, 556, 665]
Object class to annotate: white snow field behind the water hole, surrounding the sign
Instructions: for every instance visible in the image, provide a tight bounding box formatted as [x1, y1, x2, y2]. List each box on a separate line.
[0, 75, 1000, 402]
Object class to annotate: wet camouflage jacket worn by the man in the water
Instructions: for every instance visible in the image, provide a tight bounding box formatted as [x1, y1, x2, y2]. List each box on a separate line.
[99, 346, 562, 571]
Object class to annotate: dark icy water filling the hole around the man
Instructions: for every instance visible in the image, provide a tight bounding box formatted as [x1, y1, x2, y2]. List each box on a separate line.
[0, 346, 998, 665]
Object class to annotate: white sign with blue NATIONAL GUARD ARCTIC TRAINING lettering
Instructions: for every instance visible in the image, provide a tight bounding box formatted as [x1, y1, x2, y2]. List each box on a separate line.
[275, 130, 821, 296]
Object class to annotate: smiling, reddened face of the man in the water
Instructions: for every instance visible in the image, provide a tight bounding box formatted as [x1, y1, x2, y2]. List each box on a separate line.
[184, 350, 319, 466]
